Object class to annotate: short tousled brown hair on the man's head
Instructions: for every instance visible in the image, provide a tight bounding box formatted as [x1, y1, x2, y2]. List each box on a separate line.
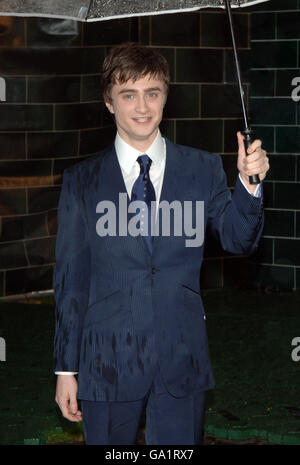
[101, 42, 170, 102]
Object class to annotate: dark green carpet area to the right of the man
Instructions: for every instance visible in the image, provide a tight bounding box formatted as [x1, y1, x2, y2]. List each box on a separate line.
[204, 291, 300, 444]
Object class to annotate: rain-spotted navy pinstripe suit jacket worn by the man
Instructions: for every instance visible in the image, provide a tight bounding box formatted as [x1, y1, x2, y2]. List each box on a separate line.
[54, 139, 263, 401]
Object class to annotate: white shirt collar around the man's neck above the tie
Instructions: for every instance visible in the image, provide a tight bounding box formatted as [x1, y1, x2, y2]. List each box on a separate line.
[115, 131, 166, 174]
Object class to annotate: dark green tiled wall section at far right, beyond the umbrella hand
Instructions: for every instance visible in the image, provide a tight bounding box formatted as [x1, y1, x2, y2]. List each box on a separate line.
[249, 0, 300, 289]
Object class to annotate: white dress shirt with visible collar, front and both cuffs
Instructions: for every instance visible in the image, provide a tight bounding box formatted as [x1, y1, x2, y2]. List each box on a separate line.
[55, 131, 260, 375]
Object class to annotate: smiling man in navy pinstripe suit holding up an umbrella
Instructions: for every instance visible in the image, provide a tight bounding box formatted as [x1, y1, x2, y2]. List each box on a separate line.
[54, 44, 269, 444]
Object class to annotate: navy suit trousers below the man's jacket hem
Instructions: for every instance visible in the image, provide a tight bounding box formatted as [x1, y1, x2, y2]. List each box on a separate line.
[81, 370, 205, 445]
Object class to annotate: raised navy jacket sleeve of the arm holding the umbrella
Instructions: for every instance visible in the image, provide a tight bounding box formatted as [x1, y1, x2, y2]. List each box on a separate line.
[208, 152, 264, 255]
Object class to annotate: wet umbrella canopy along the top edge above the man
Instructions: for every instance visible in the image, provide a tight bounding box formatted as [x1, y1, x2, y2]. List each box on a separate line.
[0, 0, 268, 22]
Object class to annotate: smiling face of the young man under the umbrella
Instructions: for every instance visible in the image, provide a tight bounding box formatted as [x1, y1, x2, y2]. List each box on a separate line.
[106, 76, 167, 151]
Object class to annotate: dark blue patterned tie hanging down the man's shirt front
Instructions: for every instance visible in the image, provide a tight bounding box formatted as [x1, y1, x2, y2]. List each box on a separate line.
[131, 155, 155, 253]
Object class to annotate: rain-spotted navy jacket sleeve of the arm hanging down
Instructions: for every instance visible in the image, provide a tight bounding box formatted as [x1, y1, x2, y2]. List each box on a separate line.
[53, 170, 90, 371]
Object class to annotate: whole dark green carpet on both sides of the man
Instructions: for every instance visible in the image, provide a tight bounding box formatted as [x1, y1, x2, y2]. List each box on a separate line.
[0, 290, 300, 445]
